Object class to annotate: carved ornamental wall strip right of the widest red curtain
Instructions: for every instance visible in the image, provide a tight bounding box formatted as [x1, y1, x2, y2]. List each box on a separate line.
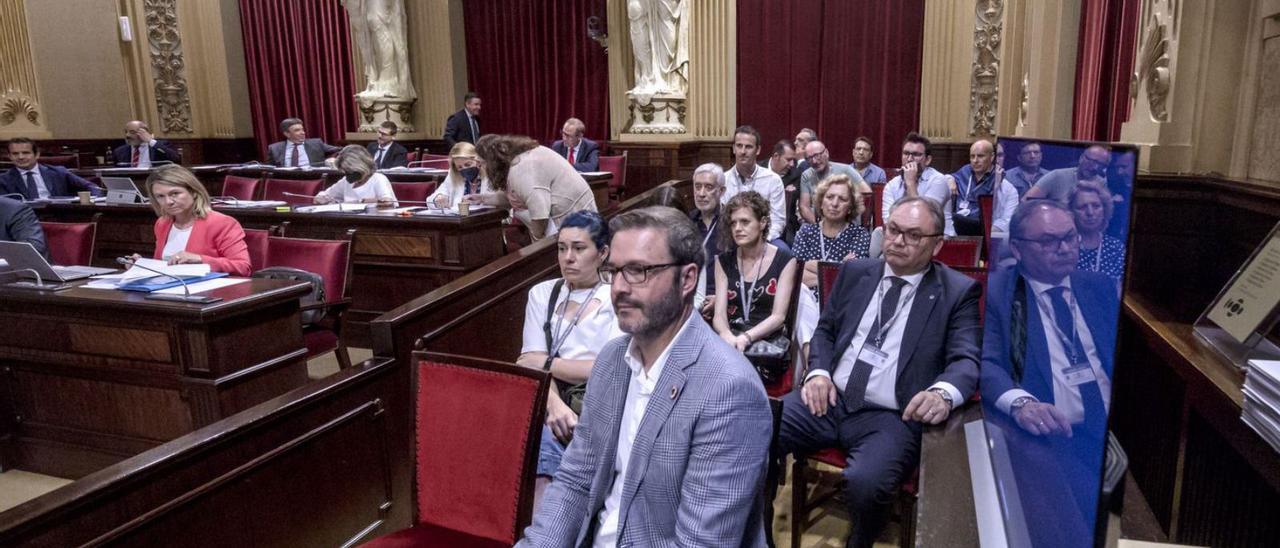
[969, 0, 1005, 136]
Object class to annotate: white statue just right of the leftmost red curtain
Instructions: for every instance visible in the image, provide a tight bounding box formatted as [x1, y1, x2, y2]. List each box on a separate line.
[343, 0, 417, 100]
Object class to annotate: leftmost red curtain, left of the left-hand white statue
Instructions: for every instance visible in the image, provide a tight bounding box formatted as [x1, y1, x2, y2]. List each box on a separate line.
[239, 0, 357, 157]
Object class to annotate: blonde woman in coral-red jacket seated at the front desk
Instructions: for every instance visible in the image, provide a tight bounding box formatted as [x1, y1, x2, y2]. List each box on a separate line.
[147, 165, 250, 277]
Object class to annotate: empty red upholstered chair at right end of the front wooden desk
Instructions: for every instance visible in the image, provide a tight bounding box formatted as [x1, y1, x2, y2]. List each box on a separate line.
[264, 230, 356, 369]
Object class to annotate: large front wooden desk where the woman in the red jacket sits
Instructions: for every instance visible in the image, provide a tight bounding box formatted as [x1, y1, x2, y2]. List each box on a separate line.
[0, 279, 310, 478]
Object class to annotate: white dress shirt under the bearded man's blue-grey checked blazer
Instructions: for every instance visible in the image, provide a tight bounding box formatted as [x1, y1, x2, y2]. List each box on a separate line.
[594, 311, 698, 548]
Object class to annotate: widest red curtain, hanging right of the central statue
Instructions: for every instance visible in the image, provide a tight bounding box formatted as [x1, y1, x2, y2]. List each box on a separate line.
[737, 0, 926, 165]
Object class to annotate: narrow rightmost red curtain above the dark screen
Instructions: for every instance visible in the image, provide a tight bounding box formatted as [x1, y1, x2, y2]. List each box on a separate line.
[1071, 0, 1139, 141]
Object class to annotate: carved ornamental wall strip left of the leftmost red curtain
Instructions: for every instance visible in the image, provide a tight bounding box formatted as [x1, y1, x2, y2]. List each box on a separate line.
[142, 0, 193, 133]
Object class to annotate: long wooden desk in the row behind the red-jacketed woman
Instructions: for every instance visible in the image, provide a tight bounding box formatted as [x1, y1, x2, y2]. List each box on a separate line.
[36, 204, 507, 347]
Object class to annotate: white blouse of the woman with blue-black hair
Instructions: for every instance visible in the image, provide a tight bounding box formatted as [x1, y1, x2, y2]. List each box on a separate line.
[520, 279, 622, 360]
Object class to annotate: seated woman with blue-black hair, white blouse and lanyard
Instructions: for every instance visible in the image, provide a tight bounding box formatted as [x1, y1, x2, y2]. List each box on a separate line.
[516, 211, 622, 507]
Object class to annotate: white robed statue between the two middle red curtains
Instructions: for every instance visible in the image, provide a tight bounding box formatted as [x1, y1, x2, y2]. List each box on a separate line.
[627, 0, 689, 102]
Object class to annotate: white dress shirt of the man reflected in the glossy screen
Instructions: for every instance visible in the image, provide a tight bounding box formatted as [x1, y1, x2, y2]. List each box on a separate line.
[996, 277, 1111, 424]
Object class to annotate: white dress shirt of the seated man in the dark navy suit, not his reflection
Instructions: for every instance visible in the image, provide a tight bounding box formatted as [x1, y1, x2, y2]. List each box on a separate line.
[805, 264, 961, 410]
